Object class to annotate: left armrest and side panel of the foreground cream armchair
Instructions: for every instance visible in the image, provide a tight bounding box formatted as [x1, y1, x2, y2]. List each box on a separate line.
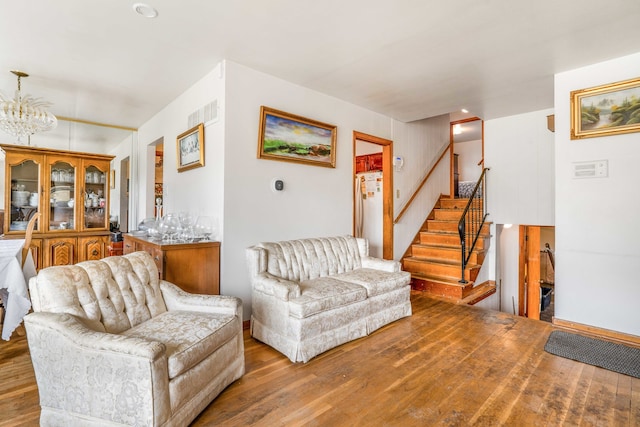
[24, 312, 171, 425]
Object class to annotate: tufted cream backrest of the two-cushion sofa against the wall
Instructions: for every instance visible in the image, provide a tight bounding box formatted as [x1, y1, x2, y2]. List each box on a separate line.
[256, 236, 367, 281]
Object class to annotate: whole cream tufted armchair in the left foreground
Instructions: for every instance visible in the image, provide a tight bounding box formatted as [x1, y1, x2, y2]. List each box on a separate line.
[25, 252, 245, 426]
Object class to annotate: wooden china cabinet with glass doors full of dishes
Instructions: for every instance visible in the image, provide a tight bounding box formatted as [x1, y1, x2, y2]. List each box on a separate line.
[0, 144, 113, 269]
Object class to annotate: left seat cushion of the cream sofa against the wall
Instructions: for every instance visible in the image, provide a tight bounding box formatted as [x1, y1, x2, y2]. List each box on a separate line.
[289, 277, 367, 319]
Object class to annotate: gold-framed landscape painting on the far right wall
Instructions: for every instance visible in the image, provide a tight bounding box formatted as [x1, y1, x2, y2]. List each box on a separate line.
[571, 78, 640, 139]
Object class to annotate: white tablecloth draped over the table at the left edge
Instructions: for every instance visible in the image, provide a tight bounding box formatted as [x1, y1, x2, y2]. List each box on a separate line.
[0, 239, 36, 341]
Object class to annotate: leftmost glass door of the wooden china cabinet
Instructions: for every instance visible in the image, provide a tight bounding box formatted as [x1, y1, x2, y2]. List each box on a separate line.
[5, 158, 42, 231]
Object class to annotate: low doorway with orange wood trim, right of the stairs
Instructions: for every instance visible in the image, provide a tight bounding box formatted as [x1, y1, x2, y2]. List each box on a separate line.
[518, 225, 555, 322]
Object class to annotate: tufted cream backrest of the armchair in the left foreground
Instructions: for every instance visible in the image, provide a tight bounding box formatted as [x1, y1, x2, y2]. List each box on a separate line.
[29, 252, 167, 334]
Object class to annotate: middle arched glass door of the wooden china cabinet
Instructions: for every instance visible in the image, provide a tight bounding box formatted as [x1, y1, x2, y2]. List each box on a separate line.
[49, 159, 78, 230]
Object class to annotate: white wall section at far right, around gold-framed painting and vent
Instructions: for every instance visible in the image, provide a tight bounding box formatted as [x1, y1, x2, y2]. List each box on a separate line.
[555, 53, 640, 335]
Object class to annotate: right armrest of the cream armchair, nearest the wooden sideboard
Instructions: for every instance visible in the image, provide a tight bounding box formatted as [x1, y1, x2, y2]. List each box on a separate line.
[160, 280, 242, 320]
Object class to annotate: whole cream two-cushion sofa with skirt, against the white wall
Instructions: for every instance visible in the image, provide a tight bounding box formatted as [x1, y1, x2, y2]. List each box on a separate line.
[246, 236, 411, 362]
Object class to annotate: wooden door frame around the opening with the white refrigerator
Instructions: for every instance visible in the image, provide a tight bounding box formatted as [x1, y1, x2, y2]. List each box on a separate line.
[351, 131, 393, 259]
